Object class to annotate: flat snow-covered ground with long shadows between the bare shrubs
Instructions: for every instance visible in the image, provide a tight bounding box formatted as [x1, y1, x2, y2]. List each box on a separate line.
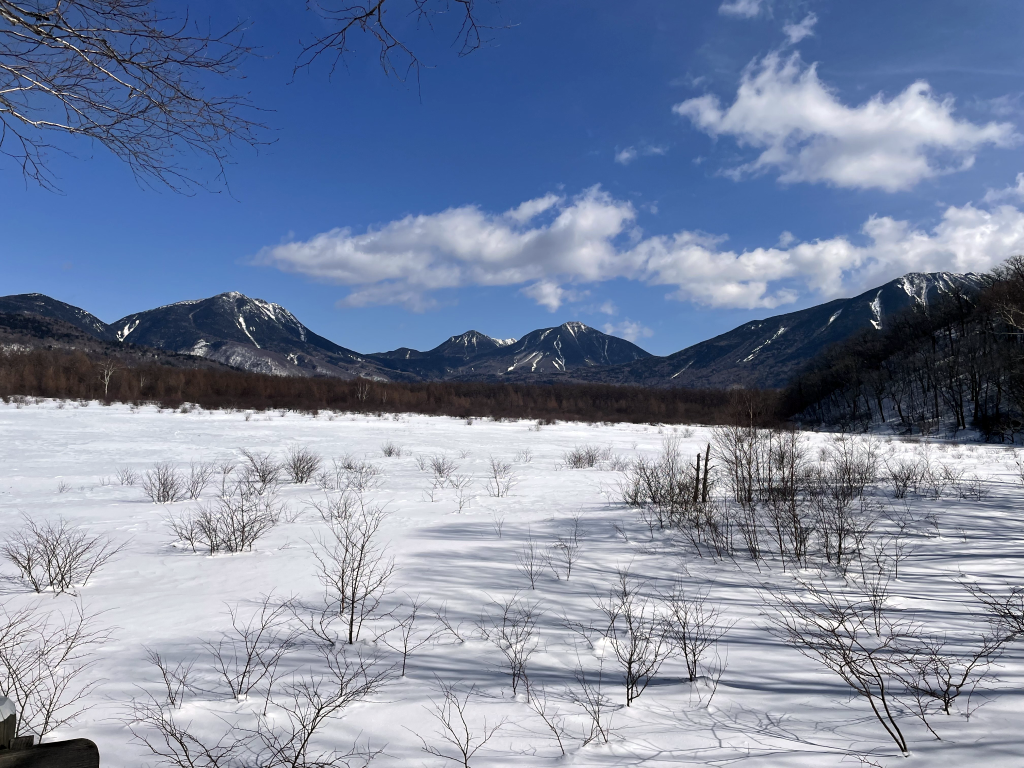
[0, 401, 1024, 768]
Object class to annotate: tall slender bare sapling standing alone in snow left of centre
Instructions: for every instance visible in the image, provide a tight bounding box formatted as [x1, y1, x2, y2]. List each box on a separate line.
[313, 498, 394, 645]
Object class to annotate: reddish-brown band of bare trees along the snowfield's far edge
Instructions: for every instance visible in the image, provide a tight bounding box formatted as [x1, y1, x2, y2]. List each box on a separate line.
[0, 349, 777, 424]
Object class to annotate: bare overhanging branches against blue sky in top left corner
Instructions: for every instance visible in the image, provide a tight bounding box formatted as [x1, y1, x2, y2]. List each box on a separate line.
[0, 0, 262, 191]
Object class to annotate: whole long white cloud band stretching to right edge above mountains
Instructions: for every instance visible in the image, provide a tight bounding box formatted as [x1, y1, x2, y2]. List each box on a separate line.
[254, 188, 1024, 314]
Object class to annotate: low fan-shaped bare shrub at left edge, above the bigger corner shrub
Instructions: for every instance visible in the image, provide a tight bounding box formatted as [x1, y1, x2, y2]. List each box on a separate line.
[0, 517, 124, 594]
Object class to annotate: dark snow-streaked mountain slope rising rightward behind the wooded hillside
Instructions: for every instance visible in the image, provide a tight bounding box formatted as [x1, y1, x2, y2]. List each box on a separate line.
[594, 272, 986, 388]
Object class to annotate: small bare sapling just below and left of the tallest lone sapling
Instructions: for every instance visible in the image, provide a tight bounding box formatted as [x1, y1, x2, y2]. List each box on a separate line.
[206, 595, 296, 698]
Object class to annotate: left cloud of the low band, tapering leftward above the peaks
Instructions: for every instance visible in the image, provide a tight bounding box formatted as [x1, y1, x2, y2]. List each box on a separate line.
[255, 187, 636, 310]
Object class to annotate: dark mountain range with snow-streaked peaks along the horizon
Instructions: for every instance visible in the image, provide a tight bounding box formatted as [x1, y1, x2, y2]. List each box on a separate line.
[0, 272, 987, 388]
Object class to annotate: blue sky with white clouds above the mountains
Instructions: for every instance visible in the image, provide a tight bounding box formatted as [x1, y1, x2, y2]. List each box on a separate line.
[0, 0, 1024, 354]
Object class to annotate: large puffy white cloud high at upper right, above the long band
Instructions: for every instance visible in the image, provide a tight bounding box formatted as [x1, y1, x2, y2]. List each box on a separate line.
[673, 53, 1020, 191]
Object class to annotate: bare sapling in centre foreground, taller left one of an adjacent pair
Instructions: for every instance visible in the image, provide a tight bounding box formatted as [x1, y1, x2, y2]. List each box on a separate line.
[600, 570, 671, 707]
